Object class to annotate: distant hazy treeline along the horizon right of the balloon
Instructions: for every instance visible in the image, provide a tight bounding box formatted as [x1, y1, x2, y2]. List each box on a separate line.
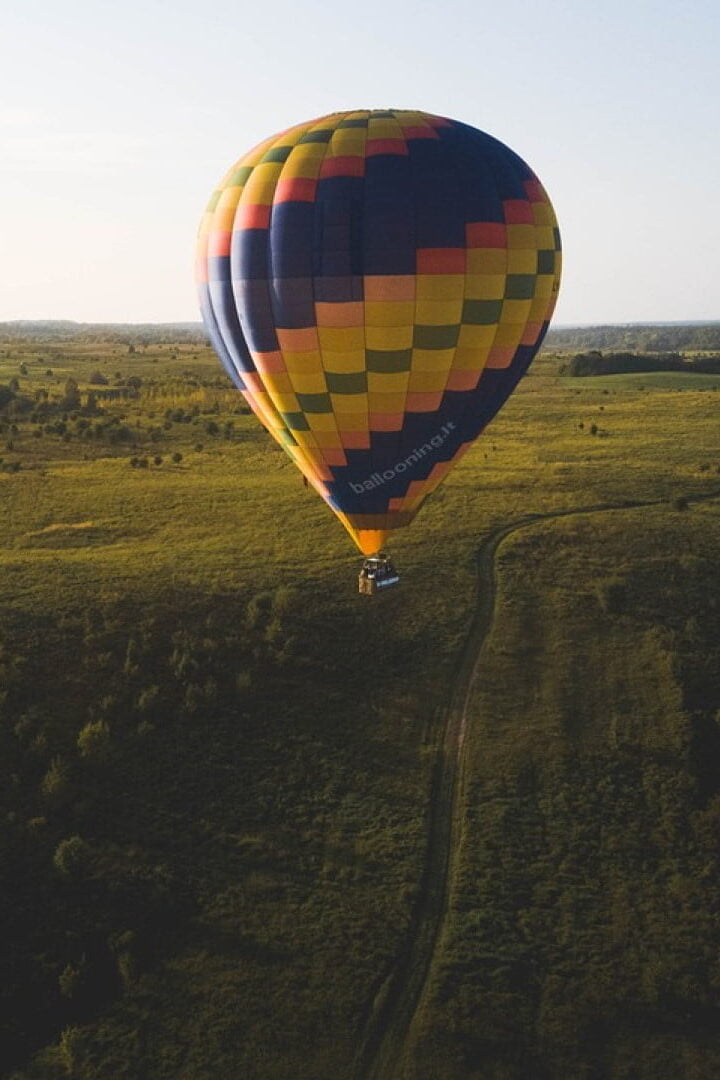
[545, 322, 720, 352]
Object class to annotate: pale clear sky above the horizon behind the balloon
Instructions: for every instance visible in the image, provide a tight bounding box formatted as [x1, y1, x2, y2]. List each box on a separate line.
[0, 0, 720, 325]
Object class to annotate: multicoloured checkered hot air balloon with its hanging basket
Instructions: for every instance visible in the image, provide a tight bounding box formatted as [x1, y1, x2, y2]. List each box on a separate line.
[198, 109, 560, 592]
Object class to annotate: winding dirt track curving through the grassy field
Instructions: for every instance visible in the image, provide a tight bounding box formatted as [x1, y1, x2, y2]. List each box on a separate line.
[353, 491, 720, 1080]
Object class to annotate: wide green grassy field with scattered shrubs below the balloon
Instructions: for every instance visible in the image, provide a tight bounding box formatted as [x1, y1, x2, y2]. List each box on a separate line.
[0, 339, 720, 1080]
